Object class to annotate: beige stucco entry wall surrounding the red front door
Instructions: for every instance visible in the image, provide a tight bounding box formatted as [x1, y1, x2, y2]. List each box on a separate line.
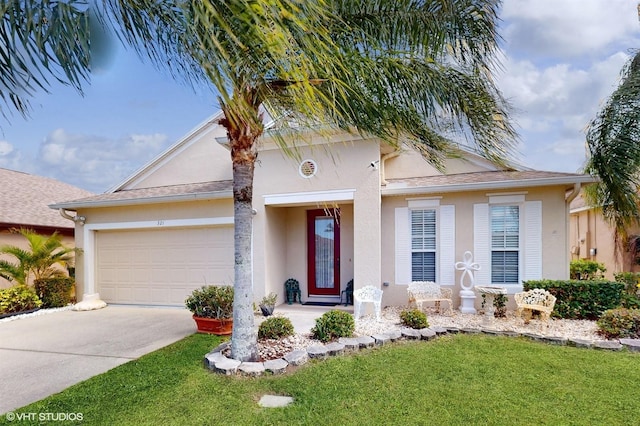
[254, 137, 381, 301]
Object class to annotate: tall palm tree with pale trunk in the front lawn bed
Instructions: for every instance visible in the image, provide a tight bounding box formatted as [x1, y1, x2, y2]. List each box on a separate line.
[104, 0, 515, 361]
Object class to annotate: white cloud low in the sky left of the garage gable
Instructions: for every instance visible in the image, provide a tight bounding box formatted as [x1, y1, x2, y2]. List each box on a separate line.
[36, 129, 169, 192]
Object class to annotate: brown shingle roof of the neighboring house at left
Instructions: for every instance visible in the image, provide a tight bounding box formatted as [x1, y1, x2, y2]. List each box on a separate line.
[0, 168, 93, 229]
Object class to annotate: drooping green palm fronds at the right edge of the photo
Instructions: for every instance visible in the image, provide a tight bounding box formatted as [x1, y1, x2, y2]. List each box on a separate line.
[585, 51, 640, 247]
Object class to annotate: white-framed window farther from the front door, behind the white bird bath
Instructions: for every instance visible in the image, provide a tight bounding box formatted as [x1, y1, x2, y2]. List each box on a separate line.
[490, 206, 520, 284]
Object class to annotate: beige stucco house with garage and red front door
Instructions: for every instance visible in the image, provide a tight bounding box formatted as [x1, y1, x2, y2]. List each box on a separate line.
[51, 115, 591, 312]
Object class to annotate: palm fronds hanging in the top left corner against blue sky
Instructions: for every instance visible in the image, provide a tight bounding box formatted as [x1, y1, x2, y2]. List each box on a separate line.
[0, 0, 92, 118]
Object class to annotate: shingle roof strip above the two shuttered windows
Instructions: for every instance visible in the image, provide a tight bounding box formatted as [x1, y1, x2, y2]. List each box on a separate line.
[382, 170, 595, 195]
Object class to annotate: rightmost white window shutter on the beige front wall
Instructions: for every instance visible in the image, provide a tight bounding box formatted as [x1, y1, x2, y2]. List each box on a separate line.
[522, 201, 542, 281]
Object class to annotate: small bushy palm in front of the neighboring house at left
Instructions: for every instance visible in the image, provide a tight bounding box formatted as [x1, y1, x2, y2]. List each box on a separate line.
[0, 229, 76, 285]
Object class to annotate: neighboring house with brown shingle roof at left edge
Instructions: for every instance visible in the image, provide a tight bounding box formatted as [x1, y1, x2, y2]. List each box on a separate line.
[0, 168, 93, 288]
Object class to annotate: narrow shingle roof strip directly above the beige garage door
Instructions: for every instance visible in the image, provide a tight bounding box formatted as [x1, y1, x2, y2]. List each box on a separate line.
[51, 180, 233, 209]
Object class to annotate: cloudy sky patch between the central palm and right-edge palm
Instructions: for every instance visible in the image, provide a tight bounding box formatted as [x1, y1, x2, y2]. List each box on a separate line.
[497, 0, 640, 172]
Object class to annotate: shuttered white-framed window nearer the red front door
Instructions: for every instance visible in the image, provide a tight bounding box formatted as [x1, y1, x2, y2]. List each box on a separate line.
[411, 209, 437, 281]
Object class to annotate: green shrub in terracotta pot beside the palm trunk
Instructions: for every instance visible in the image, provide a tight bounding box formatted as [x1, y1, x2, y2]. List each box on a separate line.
[185, 285, 233, 336]
